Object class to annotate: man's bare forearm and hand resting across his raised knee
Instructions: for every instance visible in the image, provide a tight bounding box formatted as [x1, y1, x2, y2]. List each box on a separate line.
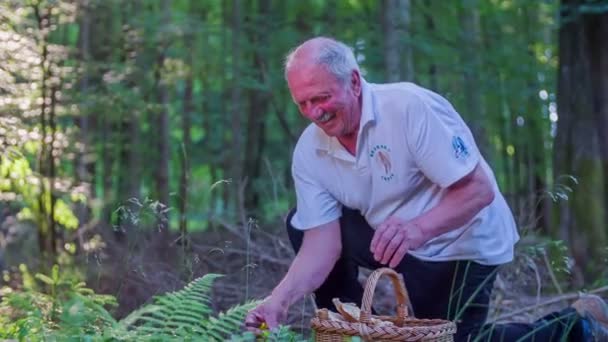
[370, 164, 494, 267]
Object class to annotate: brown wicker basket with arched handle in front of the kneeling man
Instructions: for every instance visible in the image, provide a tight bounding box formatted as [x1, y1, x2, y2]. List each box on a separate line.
[311, 268, 456, 342]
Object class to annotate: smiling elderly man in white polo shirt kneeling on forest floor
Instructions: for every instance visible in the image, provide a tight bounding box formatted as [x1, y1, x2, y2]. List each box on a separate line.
[246, 37, 608, 341]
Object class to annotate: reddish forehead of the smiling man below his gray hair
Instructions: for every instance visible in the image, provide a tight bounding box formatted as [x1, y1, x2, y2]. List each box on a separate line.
[287, 65, 337, 100]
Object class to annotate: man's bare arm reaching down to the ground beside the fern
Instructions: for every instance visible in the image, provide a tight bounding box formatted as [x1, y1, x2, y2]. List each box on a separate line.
[245, 220, 342, 328]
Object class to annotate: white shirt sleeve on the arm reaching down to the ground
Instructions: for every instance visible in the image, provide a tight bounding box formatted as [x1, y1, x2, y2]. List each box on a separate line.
[291, 148, 342, 230]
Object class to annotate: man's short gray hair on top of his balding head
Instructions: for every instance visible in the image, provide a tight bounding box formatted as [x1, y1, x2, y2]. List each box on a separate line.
[285, 37, 359, 83]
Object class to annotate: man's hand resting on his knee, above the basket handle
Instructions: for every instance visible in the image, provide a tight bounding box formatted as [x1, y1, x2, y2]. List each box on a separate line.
[370, 216, 429, 267]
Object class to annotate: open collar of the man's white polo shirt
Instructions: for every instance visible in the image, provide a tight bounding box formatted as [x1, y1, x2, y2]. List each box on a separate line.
[313, 77, 376, 158]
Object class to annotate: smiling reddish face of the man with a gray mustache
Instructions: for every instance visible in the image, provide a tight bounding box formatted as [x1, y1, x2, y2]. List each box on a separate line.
[287, 65, 361, 138]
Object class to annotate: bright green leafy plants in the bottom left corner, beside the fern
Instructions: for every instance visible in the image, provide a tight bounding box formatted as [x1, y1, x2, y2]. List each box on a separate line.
[0, 265, 116, 341]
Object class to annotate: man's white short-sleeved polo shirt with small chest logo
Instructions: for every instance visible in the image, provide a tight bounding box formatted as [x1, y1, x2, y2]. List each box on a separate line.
[291, 80, 519, 265]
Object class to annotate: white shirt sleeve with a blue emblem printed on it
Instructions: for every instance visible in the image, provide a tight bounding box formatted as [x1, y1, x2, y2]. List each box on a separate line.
[405, 98, 480, 188]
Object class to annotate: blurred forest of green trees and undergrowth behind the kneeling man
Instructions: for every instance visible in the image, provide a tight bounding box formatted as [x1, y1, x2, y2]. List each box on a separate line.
[0, 0, 608, 338]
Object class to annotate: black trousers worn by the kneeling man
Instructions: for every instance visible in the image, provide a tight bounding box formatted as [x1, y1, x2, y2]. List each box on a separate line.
[286, 208, 583, 342]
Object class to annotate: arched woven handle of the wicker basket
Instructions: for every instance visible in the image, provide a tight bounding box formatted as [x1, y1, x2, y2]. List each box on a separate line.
[359, 267, 410, 326]
